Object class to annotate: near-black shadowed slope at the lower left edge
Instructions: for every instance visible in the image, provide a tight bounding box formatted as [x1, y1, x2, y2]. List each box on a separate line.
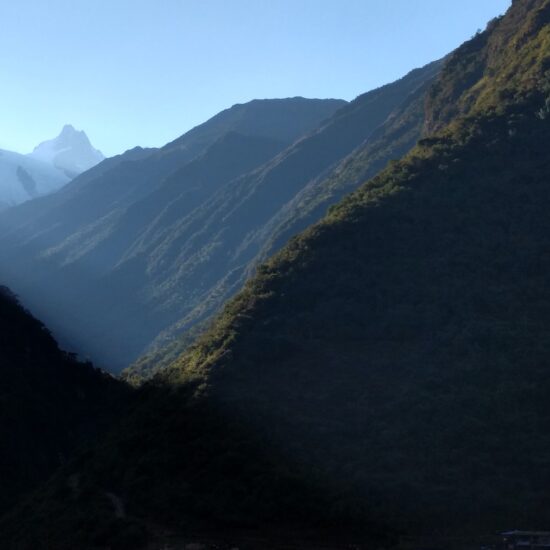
[0, 287, 127, 513]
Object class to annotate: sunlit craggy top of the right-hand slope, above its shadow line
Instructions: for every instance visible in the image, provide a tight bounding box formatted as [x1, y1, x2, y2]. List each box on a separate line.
[427, 0, 550, 131]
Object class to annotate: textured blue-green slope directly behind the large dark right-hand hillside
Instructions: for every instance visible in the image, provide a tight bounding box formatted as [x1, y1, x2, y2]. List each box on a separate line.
[124, 62, 441, 381]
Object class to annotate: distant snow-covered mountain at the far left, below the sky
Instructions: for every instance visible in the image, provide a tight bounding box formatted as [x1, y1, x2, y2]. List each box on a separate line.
[0, 125, 105, 210]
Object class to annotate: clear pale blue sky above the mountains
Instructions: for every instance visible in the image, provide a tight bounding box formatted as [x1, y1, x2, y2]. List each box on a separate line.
[0, 0, 510, 155]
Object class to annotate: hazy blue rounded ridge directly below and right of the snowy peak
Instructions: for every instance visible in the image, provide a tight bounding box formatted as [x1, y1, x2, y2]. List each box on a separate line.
[0, 98, 345, 370]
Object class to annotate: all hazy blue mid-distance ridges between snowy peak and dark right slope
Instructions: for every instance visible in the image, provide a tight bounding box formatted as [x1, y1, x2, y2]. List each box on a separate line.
[0, 77, 440, 373]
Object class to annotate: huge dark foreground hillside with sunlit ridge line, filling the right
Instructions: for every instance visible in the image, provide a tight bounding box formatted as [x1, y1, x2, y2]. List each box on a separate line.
[0, 0, 550, 548]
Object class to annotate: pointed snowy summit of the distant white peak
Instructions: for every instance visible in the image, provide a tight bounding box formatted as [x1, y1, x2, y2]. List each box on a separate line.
[29, 124, 105, 178]
